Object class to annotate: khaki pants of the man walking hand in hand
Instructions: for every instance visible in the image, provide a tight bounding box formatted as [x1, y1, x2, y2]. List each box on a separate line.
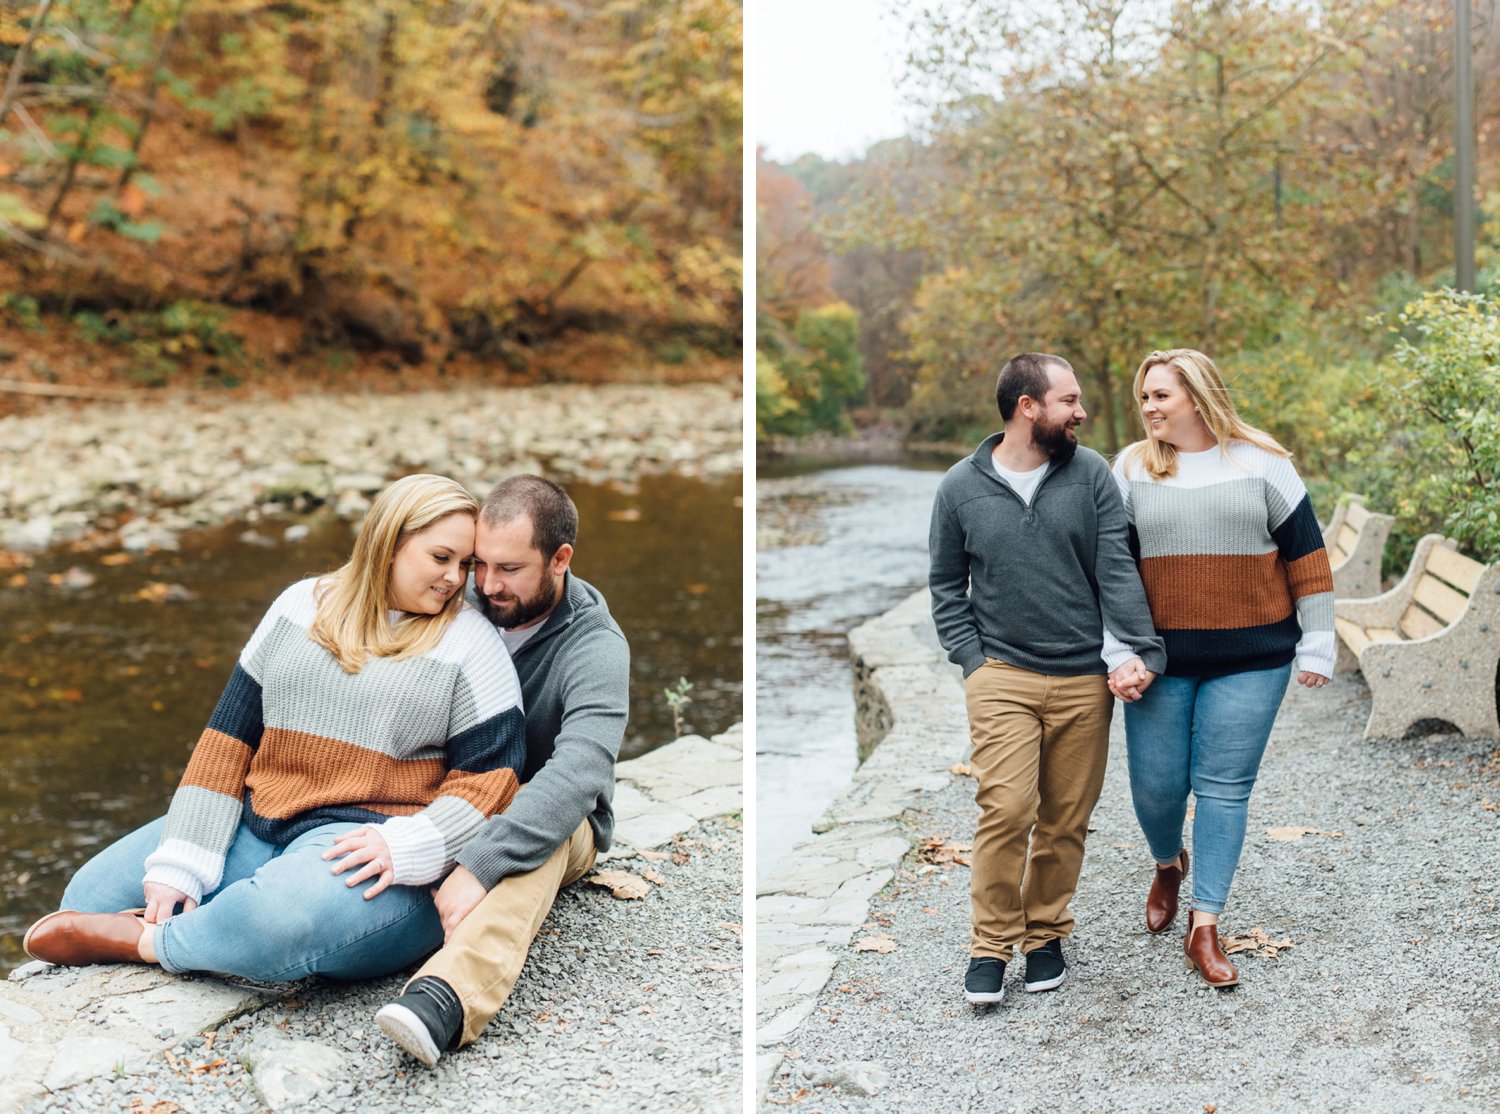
[965, 658, 1115, 961]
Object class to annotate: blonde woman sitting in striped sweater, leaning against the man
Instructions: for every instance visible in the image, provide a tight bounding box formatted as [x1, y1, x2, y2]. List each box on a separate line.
[26, 475, 525, 982]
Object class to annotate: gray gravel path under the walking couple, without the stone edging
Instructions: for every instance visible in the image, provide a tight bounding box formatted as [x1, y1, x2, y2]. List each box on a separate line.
[768, 679, 1500, 1114]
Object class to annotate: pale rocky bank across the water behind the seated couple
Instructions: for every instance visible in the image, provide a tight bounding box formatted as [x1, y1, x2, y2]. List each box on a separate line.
[0, 384, 744, 552]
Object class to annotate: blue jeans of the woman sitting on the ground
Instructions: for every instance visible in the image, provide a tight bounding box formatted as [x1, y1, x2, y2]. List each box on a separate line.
[62, 817, 443, 982]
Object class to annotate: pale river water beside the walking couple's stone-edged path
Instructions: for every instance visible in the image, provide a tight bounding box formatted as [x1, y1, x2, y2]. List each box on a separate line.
[756, 460, 951, 879]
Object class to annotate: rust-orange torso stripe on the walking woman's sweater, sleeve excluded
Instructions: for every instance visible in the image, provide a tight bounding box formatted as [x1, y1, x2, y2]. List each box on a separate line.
[1140, 550, 1293, 630]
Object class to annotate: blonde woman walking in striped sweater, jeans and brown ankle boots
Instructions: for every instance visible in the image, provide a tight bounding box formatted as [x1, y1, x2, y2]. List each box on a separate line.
[1113, 348, 1334, 987]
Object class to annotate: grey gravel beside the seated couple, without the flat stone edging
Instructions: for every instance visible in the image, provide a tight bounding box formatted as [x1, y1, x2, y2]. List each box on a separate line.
[27, 819, 743, 1114]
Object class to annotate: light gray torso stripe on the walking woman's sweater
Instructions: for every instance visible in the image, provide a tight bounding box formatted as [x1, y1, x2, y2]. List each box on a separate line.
[1130, 477, 1286, 558]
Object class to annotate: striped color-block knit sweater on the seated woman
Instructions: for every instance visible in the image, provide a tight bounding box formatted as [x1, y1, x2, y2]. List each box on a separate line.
[146, 580, 527, 900]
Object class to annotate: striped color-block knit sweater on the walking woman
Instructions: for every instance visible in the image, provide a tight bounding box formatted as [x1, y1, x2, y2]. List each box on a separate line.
[1115, 441, 1334, 676]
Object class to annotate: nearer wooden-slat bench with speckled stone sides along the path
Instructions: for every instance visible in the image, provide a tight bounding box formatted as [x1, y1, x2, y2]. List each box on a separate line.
[1334, 534, 1500, 739]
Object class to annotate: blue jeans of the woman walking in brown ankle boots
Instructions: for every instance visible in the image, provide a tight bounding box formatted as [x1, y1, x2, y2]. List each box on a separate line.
[1125, 664, 1292, 913]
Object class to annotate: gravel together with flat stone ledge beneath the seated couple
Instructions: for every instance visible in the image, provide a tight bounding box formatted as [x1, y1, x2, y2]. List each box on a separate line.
[0, 726, 744, 1114]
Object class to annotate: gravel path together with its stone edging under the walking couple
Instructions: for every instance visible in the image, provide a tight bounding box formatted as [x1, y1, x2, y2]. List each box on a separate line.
[758, 594, 1500, 1114]
